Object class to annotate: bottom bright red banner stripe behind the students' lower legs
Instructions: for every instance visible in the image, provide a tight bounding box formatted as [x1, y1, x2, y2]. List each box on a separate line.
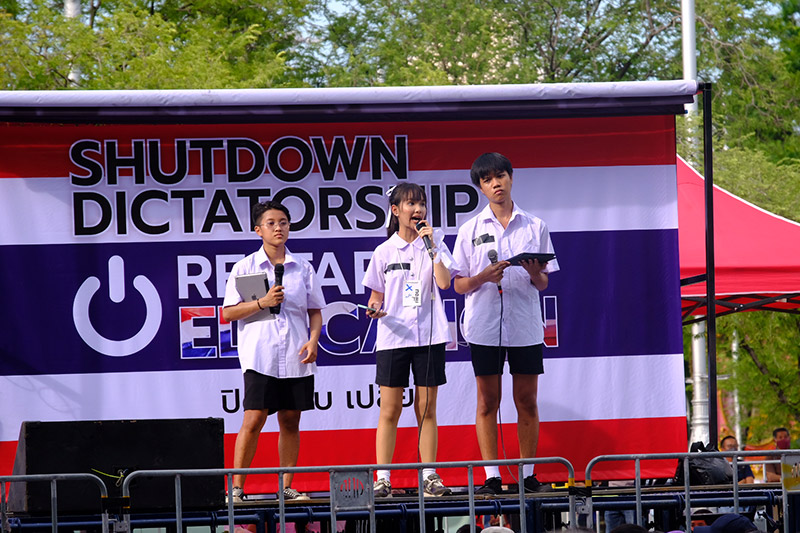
[225, 417, 687, 494]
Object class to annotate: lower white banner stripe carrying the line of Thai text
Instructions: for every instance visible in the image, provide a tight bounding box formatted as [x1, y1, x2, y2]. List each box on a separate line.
[0, 354, 685, 441]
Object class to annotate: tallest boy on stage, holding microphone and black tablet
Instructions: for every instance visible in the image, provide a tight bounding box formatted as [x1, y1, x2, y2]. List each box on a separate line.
[453, 152, 558, 494]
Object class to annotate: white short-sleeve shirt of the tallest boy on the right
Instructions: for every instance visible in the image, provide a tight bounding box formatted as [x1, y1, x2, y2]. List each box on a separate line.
[453, 205, 559, 346]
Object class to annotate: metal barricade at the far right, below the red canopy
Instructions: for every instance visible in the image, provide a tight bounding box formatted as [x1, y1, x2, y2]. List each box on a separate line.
[586, 450, 800, 533]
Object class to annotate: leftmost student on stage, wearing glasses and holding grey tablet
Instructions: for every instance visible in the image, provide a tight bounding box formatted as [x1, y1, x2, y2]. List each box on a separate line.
[222, 201, 325, 503]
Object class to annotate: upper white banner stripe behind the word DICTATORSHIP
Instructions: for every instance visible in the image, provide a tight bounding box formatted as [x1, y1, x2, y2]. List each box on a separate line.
[0, 165, 678, 245]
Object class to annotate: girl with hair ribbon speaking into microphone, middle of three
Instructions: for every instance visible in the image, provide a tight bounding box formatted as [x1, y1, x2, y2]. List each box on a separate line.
[363, 183, 454, 497]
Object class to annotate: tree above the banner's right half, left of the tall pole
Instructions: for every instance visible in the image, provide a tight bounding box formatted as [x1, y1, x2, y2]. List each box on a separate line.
[304, 0, 680, 85]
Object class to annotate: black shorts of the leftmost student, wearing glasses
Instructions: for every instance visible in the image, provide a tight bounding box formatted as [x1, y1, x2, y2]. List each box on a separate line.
[242, 370, 314, 414]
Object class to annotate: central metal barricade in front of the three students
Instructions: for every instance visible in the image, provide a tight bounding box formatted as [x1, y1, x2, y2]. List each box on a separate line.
[122, 457, 576, 533]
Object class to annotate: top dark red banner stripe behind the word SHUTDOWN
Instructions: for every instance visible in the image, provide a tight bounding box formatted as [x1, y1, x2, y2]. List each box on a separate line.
[0, 115, 675, 179]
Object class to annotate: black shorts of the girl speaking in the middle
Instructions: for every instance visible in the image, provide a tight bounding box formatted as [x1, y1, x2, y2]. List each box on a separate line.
[375, 343, 447, 387]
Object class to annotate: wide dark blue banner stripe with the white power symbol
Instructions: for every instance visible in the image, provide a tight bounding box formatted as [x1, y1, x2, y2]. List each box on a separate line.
[0, 230, 682, 375]
